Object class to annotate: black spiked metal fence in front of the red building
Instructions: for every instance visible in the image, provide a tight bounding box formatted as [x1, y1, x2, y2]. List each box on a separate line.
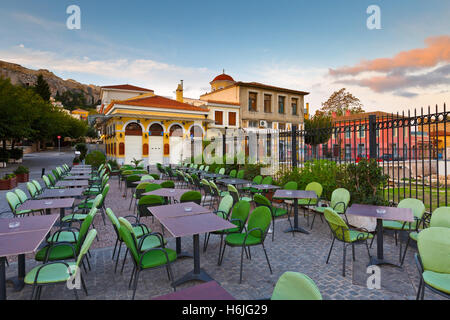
[277, 104, 450, 212]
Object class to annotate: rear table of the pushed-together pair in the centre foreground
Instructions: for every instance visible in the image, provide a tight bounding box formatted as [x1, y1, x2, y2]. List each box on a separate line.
[148, 202, 211, 258]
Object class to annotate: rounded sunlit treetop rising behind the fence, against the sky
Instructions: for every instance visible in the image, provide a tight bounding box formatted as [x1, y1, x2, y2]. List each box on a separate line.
[321, 88, 364, 117]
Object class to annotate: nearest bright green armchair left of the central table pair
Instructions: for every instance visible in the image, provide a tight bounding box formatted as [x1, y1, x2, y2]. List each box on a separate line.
[119, 217, 177, 300]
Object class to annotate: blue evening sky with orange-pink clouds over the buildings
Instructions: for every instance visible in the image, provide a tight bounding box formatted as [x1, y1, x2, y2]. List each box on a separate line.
[0, 0, 450, 112]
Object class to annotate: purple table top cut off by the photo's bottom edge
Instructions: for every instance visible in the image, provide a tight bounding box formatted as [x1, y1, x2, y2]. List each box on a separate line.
[153, 281, 236, 300]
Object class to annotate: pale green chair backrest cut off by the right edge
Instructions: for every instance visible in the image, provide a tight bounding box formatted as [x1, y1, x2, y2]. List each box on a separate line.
[417, 227, 450, 275]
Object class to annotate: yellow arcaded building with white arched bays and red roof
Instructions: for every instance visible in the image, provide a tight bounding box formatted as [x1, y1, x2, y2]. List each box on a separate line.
[100, 85, 209, 165]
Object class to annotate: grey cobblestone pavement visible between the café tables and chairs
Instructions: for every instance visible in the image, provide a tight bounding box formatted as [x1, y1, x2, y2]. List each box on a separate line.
[0, 177, 438, 300]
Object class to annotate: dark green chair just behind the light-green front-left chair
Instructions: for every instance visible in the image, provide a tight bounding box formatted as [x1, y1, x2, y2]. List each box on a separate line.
[34, 208, 97, 262]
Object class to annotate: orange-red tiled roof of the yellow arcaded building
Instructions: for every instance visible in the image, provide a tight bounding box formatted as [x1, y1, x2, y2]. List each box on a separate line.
[104, 95, 209, 113]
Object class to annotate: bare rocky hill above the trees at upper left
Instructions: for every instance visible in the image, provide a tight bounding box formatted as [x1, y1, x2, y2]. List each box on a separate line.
[0, 60, 100, 105]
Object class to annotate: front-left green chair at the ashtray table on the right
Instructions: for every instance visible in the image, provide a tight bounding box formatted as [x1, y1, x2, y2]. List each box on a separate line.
[324, 208, 373, 277]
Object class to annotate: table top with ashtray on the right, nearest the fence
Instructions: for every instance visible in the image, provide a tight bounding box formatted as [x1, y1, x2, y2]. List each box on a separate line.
[345, 204, 414, 222]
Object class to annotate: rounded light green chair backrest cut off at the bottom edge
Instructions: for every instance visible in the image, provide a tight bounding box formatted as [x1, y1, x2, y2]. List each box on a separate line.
[271, 271, 322, 300]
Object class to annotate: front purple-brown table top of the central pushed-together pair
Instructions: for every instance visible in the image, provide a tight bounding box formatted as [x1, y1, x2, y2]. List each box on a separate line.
[158, 213, 236, 238]
